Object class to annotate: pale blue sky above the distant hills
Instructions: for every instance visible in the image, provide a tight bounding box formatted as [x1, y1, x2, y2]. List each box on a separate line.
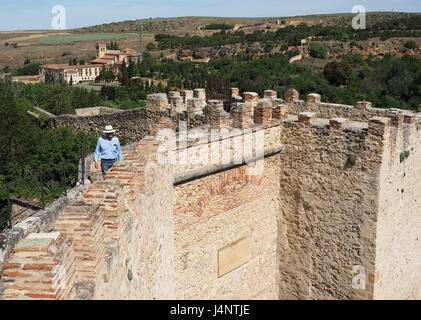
[0, 0, 421, 31]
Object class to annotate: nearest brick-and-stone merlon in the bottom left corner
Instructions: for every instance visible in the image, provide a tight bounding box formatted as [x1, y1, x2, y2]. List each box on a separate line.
[3, 232, 75, 300]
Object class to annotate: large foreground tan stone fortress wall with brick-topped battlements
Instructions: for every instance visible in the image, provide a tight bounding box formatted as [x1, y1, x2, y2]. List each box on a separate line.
[0, 88, 421, 299]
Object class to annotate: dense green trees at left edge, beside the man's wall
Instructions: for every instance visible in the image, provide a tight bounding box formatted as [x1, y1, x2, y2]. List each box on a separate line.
[0, 83, 96, 229]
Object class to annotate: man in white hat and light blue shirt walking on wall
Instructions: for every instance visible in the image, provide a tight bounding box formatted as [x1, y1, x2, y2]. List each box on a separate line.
[94, 126, 123, 177]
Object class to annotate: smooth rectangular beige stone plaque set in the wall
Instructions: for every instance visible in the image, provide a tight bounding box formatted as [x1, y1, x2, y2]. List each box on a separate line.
[218, 237, 251, 277]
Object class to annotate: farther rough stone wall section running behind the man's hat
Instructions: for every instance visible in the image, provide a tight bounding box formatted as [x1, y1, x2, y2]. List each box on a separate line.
[48, 89, 207, 143]
